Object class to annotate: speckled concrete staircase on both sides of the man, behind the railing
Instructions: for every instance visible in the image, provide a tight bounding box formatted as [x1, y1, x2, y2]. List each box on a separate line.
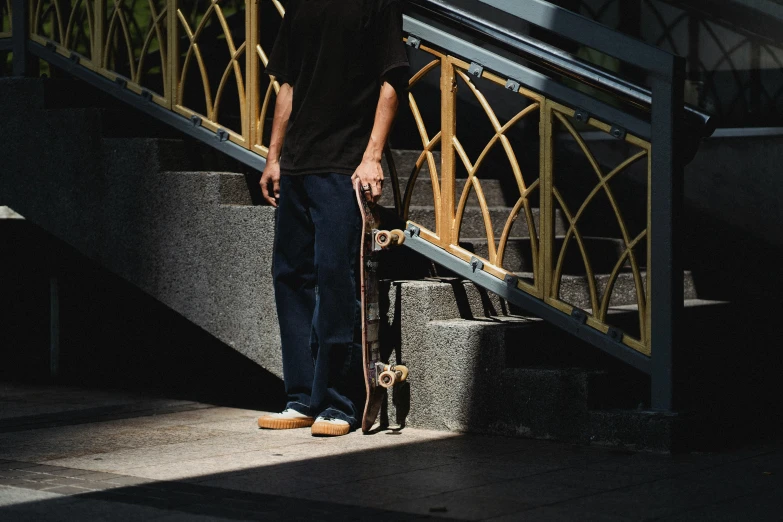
[0, 75, 716, 451]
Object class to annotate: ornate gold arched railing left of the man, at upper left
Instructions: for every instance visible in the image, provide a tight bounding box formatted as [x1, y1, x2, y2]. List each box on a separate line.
[20, 0, 285, 152]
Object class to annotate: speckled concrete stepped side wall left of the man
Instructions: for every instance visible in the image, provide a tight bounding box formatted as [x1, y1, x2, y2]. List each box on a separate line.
[0, 79, 282, 376]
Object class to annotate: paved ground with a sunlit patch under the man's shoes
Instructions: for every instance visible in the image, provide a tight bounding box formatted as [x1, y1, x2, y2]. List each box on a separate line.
[0, 383, 783, 521]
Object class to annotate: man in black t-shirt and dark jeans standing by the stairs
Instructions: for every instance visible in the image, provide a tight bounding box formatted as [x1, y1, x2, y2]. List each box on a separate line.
[258, 0, 408, 436]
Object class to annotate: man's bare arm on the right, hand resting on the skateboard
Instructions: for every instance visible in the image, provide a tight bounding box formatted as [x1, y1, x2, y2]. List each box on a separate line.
[351, 82, 399, 201]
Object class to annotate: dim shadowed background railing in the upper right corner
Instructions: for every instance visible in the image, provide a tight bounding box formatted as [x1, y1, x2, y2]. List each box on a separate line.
[578, 0, 783, 127]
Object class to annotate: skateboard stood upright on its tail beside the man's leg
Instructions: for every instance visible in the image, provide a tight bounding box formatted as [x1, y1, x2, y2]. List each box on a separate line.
[356, 187, 408, 433]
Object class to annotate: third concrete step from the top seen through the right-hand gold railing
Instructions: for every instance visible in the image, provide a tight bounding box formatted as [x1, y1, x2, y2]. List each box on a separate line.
[408, 206, 565, 238]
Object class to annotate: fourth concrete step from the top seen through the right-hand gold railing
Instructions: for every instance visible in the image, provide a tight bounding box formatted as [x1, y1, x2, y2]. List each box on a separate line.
[460, 237, 632, 274]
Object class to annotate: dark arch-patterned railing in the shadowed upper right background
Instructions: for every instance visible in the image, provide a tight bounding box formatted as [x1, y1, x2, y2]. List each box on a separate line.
[579, 0, 783, 126]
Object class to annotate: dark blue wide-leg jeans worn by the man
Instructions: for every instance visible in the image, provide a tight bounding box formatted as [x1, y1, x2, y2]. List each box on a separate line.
[272, 174, 365, 428]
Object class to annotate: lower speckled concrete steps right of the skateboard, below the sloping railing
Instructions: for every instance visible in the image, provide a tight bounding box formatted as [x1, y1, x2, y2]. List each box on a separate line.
[386, 280, 728, 446]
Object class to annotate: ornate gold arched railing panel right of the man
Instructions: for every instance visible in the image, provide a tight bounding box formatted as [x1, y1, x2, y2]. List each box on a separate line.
[400, 45, 652, 355]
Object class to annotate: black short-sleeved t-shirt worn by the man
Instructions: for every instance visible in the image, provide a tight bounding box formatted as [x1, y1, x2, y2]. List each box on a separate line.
[266, 0, 408, 175]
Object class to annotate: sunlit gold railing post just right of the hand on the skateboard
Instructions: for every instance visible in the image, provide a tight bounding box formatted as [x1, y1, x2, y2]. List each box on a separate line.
[435, 56, 458, 247]
